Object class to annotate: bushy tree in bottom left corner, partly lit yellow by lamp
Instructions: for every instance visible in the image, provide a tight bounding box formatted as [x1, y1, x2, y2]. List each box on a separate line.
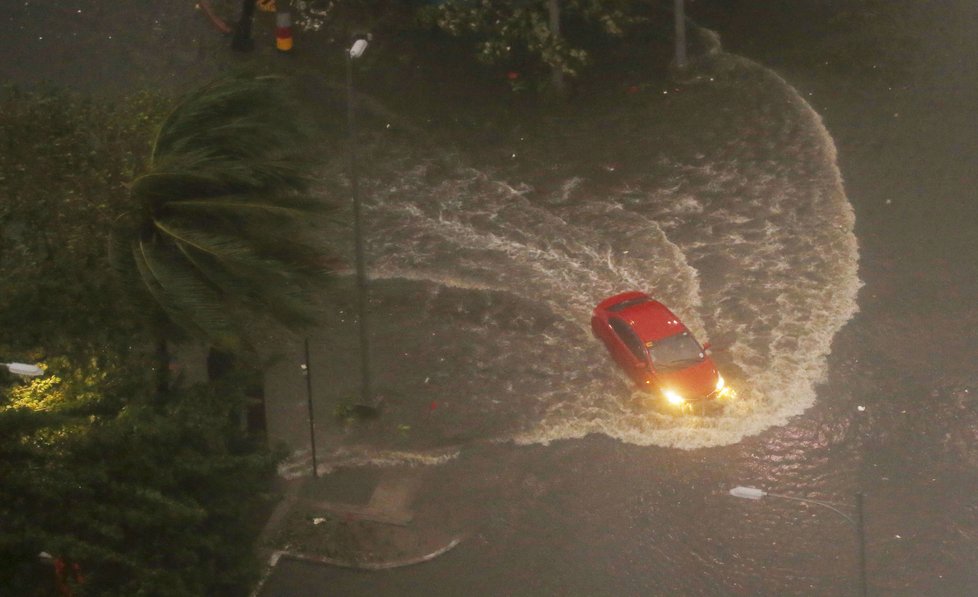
[0, 363, 275, 596]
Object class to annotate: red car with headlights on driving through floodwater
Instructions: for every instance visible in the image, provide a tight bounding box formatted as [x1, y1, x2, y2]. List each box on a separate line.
[591, 291, 733, 407]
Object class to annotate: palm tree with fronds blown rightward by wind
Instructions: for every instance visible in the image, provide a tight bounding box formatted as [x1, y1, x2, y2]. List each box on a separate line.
[111, 76, 330, 400]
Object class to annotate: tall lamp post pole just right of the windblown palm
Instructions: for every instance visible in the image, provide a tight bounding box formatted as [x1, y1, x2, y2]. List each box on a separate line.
[346, 51, 371, 405]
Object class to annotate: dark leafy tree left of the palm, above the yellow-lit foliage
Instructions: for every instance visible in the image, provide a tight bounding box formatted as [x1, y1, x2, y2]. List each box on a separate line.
[0, 89, 167, 361]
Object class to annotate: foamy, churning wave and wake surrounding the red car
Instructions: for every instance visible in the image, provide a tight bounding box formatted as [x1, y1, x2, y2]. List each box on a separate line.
[342, 47, 860, 449]
